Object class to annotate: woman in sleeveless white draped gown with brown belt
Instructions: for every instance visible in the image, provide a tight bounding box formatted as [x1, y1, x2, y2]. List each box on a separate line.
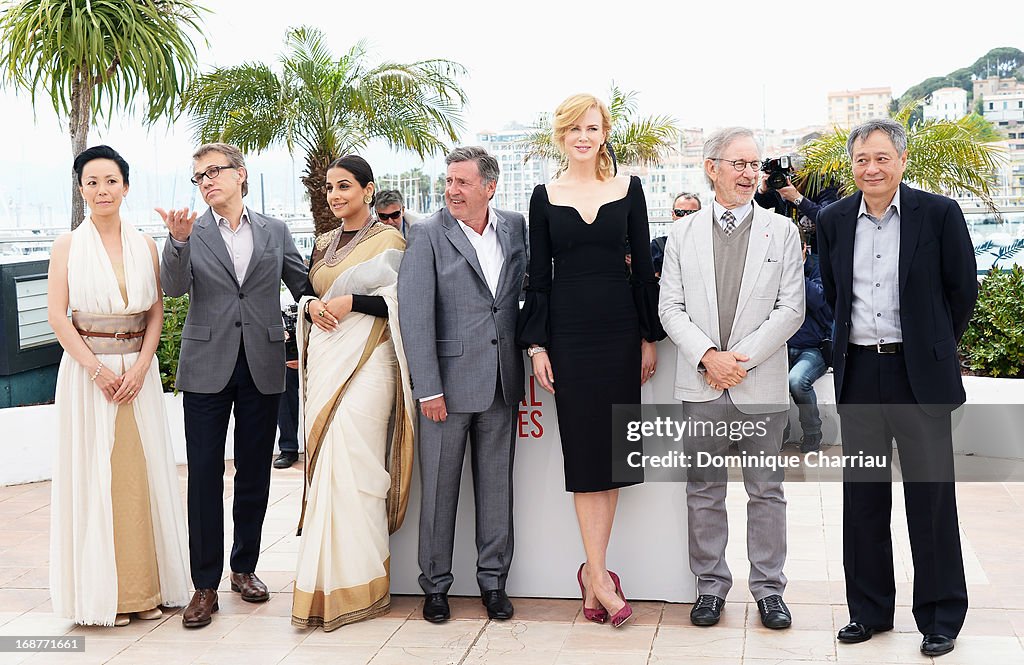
[47, 146, 188, 626]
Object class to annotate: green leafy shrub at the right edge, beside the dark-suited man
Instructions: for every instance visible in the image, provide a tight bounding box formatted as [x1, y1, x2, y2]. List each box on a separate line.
[961, 265, 1024, 378]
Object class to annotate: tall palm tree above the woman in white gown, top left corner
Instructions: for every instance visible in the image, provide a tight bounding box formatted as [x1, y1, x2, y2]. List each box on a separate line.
[0, 0, 206, 228]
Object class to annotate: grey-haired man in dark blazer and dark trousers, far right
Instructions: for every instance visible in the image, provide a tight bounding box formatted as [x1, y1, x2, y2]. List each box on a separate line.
[818, 119, 978, 656]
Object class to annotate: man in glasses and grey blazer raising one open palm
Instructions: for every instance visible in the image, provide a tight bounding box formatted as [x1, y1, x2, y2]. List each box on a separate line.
[157, 143, 308, 628]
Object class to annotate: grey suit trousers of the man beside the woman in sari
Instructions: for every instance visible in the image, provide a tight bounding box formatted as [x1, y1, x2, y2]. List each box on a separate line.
[419, 385, 519, 593]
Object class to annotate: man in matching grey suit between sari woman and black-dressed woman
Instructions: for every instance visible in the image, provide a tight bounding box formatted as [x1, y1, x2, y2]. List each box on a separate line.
[398, 148, 527, 623]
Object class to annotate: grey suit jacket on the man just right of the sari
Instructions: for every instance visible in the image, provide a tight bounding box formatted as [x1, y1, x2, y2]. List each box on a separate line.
[398, 208, 528, 413]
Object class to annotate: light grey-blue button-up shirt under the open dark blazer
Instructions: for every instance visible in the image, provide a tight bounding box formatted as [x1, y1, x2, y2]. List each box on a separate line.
[850, 190, 903, 345]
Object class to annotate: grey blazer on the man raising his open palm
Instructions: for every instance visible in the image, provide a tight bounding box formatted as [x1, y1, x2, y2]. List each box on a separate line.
[160, 208, 308, 394]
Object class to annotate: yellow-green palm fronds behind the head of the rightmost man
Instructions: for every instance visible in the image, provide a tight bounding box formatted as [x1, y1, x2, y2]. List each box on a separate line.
[798, 99, 1006, 211]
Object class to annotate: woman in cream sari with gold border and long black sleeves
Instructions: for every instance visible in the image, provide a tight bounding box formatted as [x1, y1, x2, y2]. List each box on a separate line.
[292, 155, 415, 630]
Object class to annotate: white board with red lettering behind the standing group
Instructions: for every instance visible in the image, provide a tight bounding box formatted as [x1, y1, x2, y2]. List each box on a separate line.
[391, 341, 696, 602]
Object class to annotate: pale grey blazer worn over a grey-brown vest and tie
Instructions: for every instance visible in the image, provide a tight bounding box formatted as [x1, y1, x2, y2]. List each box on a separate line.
[657, 204, 805, 413]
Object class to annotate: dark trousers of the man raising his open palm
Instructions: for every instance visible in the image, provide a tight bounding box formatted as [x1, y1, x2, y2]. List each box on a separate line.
[184, 345, 281, 589]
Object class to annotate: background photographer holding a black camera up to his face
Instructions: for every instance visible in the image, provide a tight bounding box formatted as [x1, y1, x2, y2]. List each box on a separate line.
[754, 155, 839, 260]
